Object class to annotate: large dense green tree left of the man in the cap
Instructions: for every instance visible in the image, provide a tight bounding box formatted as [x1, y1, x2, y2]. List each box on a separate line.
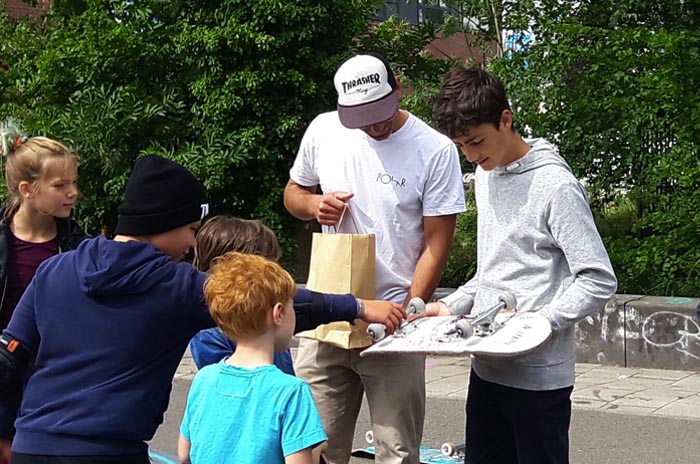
[0, 0, 377, 268]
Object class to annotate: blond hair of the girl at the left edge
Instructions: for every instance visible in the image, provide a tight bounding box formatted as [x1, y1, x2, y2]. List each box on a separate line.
[0, 122, 78, 221]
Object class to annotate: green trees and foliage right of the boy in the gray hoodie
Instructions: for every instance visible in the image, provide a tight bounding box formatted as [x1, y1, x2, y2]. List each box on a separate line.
[372, 0, 700, 295]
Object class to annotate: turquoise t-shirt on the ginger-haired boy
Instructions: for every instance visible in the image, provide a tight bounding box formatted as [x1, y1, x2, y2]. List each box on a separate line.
[180, 360, 327, 464]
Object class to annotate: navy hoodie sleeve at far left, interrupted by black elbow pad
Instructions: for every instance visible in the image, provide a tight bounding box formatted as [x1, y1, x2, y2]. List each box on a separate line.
[0, 278, 39, 438]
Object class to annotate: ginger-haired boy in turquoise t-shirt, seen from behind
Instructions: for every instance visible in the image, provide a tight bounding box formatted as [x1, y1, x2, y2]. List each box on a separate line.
[178, 252, 326, 464]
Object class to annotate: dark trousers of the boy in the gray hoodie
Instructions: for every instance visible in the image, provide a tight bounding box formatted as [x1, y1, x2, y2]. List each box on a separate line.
[464, 370, 573, 464]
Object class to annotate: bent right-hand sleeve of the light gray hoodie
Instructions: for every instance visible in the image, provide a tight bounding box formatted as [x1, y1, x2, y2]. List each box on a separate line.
[540, 183, 617, 331]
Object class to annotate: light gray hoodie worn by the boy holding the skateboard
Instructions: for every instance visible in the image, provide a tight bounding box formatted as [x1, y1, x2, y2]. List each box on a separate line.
[442, 139, 617, 390]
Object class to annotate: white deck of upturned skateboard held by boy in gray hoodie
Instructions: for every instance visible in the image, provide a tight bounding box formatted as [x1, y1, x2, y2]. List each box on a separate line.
[360, 312, 552, 358]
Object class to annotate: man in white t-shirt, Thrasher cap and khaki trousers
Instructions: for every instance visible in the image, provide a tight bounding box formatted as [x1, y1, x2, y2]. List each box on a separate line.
[284, 53, 465, 464]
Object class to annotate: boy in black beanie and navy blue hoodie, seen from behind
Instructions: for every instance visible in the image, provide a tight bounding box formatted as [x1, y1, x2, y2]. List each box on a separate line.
[0, 155, 214, 464]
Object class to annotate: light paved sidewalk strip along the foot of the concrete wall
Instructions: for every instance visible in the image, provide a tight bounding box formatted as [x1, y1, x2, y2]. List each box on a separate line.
[176, 348, 700, 420]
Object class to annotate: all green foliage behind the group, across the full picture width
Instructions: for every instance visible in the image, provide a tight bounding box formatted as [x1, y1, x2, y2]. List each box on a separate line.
[0, 0, 700, 295]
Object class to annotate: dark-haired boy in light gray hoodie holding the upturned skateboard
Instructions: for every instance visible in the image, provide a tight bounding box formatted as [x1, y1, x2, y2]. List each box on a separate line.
[428, 66, 617, 464]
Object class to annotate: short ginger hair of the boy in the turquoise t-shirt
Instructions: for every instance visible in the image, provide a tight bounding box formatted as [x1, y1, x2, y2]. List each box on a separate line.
[204, 252, 296, 340]
